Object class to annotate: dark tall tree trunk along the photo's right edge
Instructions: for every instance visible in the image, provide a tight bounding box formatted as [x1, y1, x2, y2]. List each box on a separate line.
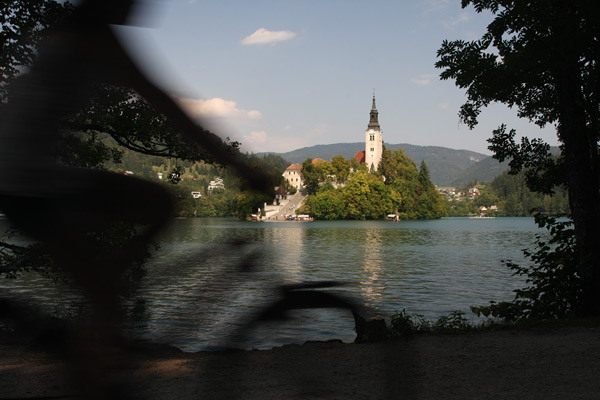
[554, 2, 600, 315]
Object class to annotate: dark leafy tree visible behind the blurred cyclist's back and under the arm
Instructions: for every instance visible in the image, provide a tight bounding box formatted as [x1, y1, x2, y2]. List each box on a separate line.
[0, 0, 252, 173]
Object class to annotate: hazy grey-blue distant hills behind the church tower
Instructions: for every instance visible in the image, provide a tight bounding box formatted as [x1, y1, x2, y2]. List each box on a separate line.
[260, 142, 507, 186]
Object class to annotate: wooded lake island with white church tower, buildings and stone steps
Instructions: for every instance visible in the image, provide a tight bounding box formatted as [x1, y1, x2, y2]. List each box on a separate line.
[152, 95, 498, 221]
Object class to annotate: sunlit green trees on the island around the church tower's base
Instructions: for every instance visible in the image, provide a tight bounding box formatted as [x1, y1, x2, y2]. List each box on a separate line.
[302, 148, 446, 220]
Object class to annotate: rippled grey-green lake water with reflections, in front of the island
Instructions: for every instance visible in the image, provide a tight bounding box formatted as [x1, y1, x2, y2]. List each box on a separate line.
[0, 218, 545, 351]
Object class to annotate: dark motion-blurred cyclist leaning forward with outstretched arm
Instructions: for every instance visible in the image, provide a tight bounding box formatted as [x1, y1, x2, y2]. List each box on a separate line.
[0, 0, 270, 398]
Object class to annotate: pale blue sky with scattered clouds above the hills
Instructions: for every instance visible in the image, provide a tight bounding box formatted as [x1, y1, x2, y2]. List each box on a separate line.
[119, 0, 557, 154]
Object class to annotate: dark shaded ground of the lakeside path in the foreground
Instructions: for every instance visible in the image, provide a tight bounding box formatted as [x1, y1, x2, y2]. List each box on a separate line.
[0, 324, 600, 400]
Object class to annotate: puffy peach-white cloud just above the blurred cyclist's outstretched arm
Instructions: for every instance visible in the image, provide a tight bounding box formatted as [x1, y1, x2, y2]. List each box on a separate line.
[177, 97, 262, 120]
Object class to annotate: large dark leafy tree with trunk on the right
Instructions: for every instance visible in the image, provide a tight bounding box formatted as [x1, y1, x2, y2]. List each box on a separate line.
[436, 0, 600, 315]
